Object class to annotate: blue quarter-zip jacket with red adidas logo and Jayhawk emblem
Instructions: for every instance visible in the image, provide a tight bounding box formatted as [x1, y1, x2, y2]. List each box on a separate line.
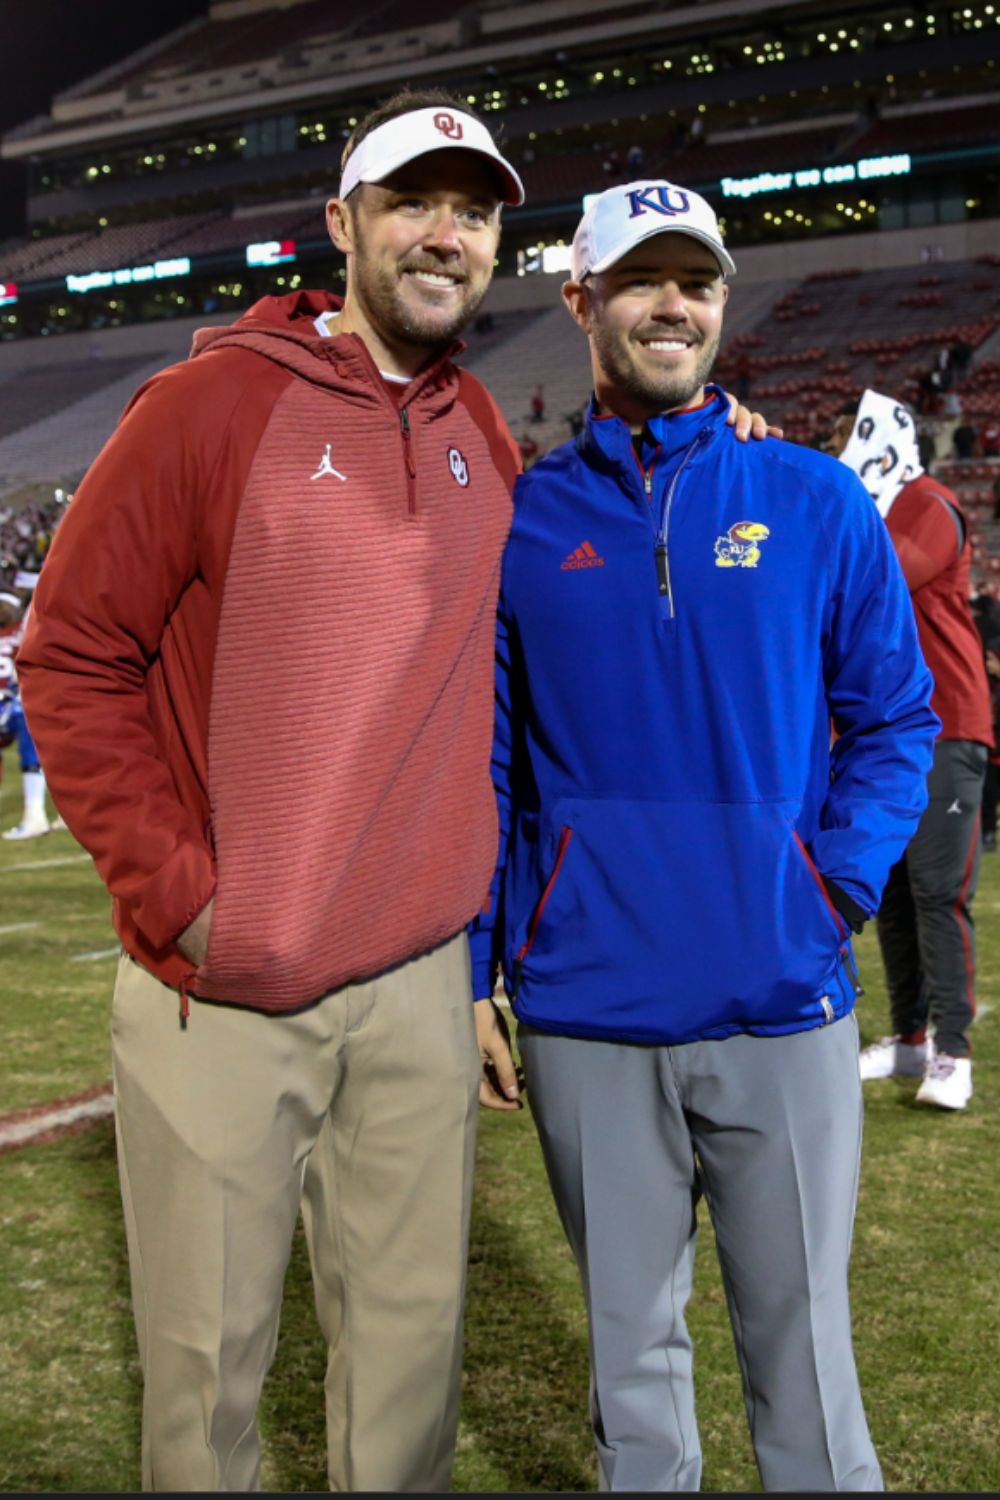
[469, 387, 939, 1044]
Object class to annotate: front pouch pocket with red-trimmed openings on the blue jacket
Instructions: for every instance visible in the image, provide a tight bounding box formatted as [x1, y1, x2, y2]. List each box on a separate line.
[505, 798, 846, 1041]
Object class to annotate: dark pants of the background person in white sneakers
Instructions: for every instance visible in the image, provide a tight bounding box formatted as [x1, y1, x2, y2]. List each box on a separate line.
[879, 740, 987, 1058]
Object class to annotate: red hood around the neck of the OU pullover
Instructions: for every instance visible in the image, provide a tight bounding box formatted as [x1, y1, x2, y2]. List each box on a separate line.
[190, 291, 463, 395]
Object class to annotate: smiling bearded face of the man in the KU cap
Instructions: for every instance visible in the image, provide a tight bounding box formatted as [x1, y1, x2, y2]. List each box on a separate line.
[562, 231, 729, 426]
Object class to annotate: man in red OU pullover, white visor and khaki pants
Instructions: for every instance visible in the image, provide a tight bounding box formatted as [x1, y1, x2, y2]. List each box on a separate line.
[18, 92, 522, 1491]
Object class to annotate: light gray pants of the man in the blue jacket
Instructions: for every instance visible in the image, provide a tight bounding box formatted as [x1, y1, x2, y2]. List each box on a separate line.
[517, 1017, 882, 1490]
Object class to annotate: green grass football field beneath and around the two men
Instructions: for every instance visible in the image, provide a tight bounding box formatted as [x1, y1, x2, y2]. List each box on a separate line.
[0, 750, 1000, 1493]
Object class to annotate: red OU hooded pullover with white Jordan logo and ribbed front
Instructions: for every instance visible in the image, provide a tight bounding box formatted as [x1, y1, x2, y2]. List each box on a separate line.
[18, 293, 519, 1010]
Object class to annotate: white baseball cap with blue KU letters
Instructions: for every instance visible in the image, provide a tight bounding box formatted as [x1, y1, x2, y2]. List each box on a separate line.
[571, 179, 736, 281]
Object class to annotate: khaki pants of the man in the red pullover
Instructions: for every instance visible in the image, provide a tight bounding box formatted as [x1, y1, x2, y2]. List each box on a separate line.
[112, 935, 480, 1491]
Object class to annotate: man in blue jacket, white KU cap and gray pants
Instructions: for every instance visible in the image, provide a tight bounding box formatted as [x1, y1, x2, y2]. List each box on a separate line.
[472, 182, 939, 1490]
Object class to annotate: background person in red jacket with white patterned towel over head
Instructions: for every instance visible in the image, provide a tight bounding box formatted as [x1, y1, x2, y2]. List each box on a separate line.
[828, 390, 993, 1110]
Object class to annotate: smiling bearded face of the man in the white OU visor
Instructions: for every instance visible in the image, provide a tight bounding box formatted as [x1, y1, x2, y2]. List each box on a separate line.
[327, 149, 499, 375]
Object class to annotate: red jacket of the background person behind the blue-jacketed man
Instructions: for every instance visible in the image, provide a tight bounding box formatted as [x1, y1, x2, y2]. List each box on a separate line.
[886, 474, 994, 746]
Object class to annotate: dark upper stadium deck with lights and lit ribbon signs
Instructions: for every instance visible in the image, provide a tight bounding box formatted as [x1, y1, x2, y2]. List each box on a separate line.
[0, 0, 1000, 338]
